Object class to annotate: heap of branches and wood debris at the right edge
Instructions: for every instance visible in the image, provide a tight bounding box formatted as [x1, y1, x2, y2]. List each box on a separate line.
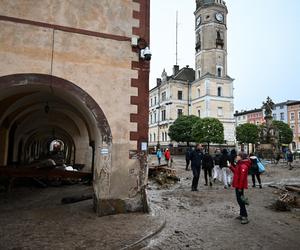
[269, 185, 300, 211]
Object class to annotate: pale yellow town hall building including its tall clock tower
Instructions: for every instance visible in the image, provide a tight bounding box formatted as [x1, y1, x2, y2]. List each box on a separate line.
[149, 0, 235, 147]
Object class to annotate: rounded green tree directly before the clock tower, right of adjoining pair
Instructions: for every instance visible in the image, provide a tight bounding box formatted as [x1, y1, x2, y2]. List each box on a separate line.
[192, 117, 224, 152]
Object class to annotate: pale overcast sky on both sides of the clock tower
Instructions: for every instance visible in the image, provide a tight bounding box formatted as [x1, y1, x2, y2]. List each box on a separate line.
[150, 0, 300, 110]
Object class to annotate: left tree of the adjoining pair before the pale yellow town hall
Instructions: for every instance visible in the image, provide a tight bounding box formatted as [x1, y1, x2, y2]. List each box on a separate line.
[169, 115, 200, 146]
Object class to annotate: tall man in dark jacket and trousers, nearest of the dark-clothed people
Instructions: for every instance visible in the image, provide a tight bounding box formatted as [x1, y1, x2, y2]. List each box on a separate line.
[191, 144, 203, 191]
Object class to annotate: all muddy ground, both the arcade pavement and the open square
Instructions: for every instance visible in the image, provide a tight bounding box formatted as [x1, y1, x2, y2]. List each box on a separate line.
[0, 157, 300, 250]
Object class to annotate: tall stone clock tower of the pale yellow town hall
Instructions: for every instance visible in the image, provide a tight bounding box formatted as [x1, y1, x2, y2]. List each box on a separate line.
[191, 0, 235, 144]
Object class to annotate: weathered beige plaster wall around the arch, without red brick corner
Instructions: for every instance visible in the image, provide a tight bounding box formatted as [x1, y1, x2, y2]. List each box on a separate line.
[0, 0, 147, 215]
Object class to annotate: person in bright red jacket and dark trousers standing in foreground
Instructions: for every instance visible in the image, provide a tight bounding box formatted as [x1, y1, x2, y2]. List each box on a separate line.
[230, 152, 251, 224]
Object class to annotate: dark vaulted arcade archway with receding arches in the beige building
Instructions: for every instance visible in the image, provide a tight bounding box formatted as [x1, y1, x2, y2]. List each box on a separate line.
[0, 74, 112, 208]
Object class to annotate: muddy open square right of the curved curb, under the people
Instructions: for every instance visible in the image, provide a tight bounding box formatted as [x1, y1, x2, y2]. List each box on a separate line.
[143, 157, 300, 250]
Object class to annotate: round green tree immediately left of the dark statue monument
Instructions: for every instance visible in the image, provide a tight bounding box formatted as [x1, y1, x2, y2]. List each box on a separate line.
[236, 123, 259, 150]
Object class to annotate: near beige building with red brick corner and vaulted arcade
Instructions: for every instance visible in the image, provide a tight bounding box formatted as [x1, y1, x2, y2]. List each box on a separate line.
[0, 0, 150, 215]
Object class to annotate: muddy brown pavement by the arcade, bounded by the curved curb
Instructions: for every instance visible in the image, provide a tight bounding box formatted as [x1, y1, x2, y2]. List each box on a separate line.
[0, 185, 165, 250]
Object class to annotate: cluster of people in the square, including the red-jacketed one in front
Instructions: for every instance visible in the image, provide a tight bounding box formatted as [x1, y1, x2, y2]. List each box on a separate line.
[186, 144, 262, 224]
